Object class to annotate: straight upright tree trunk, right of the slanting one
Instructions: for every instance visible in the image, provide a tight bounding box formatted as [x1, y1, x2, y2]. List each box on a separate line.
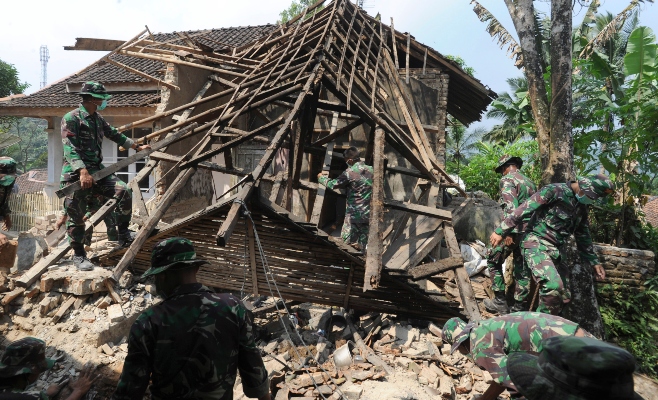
[542, 0, 574, 183]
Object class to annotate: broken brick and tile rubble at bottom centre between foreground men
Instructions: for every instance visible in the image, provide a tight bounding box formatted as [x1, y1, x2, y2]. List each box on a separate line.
[234, 303, 509, 400]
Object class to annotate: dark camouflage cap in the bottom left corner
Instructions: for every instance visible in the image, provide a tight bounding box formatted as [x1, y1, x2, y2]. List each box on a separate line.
[0, 337, 55, 378]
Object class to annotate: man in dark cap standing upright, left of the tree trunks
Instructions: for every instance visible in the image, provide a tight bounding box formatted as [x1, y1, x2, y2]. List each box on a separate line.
[484, 155, 537, 314]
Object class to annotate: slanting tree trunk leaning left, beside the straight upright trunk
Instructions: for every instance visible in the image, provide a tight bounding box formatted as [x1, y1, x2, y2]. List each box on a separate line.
[505, 0, 552, 185]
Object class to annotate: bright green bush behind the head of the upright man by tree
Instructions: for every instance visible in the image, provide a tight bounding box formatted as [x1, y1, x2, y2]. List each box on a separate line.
[459, 140, 541, 199]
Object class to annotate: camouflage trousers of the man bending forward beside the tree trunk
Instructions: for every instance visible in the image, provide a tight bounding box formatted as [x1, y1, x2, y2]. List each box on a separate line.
[523, 236, 571, 315]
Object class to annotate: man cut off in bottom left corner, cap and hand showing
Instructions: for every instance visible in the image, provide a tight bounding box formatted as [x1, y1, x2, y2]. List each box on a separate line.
[0, 337, 95, 400]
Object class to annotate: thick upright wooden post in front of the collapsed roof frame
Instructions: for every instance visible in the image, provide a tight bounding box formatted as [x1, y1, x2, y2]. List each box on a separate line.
[363, 127, 385, 292]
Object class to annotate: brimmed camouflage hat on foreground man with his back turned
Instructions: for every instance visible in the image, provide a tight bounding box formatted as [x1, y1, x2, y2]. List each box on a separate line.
[142, 237, 208, 279]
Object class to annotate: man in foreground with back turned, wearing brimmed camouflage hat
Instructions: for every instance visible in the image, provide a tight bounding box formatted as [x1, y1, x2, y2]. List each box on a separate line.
[112, 237, 270, 400]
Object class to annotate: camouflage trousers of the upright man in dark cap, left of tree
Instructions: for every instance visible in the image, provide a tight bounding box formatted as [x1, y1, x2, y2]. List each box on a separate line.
[487, 235, 530, 303]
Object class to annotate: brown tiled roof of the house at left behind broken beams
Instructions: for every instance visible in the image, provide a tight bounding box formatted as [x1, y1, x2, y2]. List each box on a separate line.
[0, 24, 277, 110]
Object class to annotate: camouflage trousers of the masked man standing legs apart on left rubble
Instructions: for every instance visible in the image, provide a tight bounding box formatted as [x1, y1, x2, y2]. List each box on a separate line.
[61, 174, 132, 251]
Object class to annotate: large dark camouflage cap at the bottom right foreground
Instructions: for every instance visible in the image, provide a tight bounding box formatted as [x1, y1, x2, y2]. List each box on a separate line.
[507, 336, 641, 400]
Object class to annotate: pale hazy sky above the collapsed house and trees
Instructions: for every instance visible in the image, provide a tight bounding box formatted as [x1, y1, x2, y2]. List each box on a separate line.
[0, 0, 658, 131]
